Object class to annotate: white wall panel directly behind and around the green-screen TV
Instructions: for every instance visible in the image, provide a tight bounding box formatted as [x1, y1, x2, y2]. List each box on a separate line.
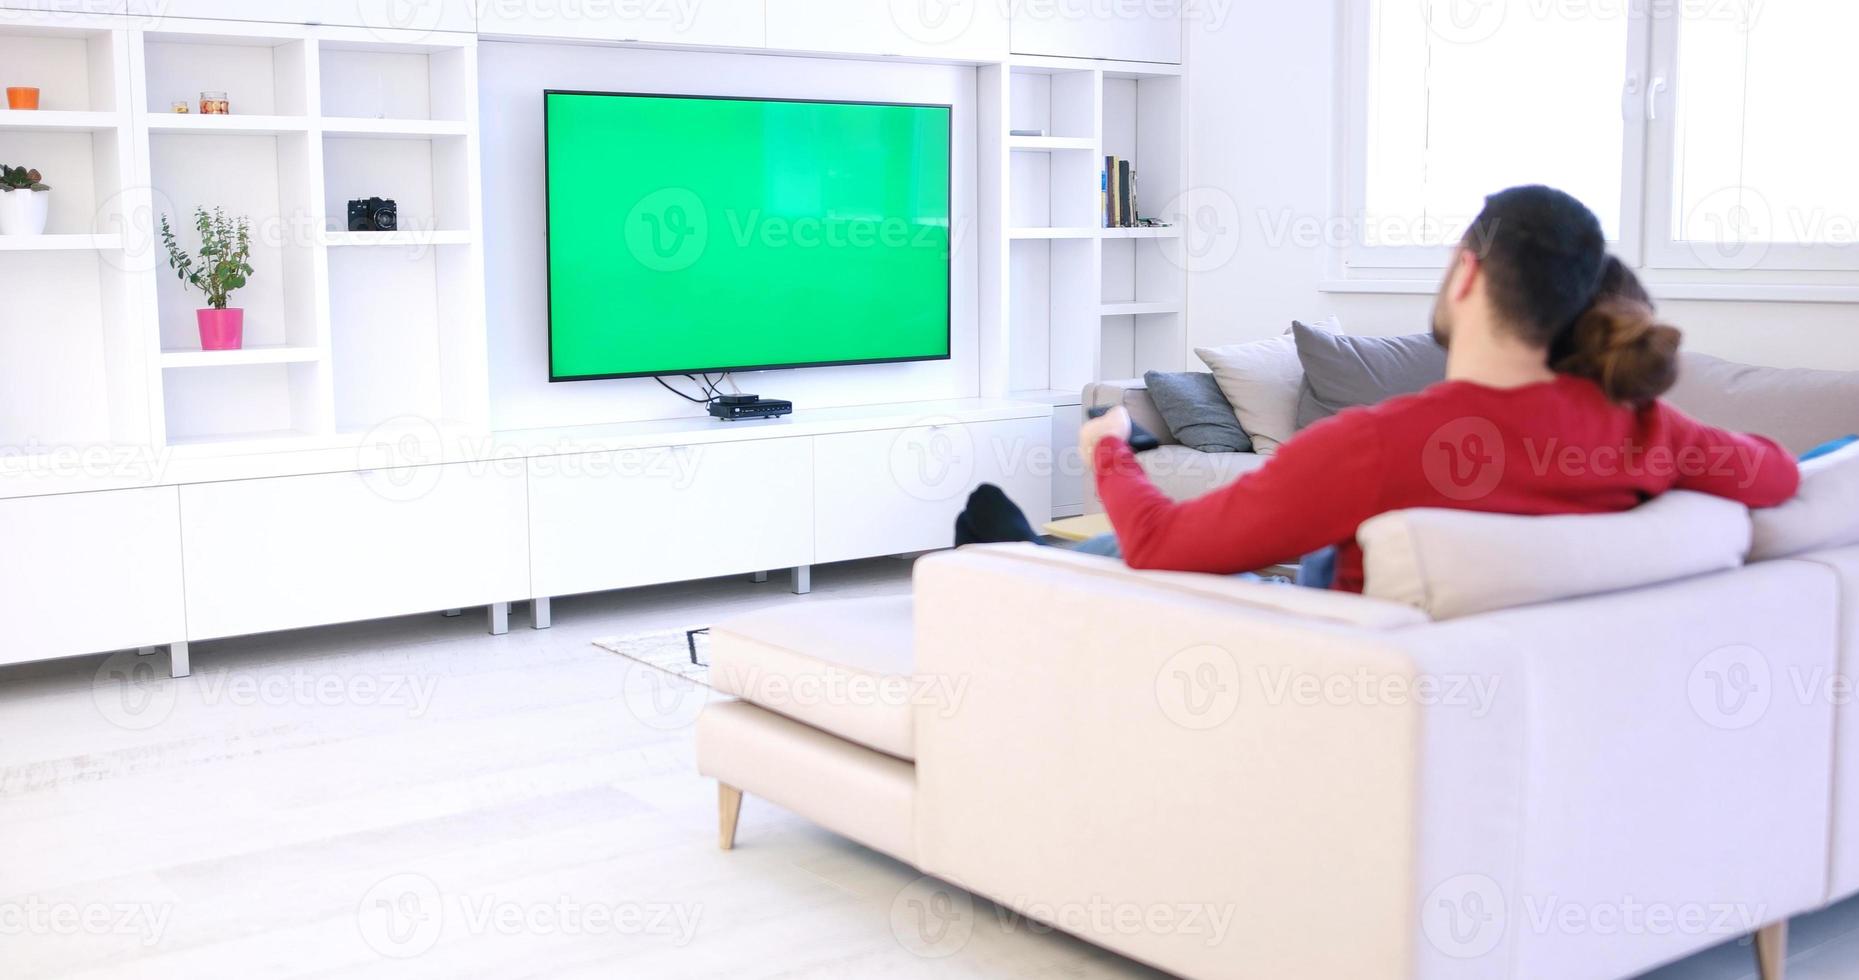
[478, 43, 980, 430]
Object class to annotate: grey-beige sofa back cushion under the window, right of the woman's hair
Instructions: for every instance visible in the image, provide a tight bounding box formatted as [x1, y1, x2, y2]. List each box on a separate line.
[1666, 351, 1859, 452]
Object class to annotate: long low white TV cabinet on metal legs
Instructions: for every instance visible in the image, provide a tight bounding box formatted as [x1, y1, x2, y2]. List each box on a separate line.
[0, 398, 1052, 675]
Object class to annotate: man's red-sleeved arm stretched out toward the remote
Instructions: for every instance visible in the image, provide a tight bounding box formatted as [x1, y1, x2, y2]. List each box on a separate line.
[1089, 413, 1381, 575]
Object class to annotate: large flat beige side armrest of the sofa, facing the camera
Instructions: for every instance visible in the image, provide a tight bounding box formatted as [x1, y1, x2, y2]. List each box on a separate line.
[916, 549, 1418, 980]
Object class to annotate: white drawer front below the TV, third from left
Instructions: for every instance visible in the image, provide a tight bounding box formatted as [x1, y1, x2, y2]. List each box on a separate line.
[530, 437, 814, 595]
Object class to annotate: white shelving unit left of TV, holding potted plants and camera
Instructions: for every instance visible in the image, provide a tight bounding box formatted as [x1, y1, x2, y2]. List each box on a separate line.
[0, 11, 489, 457]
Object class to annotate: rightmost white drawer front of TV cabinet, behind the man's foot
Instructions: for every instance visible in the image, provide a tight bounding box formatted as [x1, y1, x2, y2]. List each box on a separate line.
[814, 418, 1052, 562]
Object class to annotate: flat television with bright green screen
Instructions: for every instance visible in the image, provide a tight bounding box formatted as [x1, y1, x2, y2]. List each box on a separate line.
[543, 91, 950, 381]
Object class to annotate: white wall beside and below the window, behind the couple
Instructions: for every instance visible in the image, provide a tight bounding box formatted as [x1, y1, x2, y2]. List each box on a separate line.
[1188, 0, 1859, 370]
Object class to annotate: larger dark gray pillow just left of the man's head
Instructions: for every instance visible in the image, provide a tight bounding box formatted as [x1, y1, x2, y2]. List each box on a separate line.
[1290, 324, 1446, 430]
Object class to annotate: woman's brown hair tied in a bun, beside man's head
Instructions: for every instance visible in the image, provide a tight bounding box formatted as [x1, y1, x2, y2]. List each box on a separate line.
[1549, 255, 1684, 407]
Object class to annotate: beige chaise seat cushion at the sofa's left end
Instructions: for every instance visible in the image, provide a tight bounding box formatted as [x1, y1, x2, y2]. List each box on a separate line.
[710, 595, 918, 759]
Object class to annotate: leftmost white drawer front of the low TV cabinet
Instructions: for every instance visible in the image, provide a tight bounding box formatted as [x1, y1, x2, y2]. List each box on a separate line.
[0, 487, 186, 664]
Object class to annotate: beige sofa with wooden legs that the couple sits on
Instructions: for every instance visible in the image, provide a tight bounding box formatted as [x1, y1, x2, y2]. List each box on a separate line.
[697, 355, 1859, 980]
